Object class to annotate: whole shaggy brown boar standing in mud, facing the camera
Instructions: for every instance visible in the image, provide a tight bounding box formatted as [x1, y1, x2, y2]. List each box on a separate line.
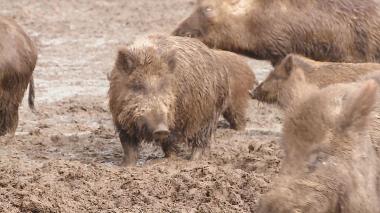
[109, 36, 230, 165]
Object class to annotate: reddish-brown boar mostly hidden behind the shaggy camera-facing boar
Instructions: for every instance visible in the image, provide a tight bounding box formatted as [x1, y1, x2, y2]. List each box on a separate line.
[214, 50, 257, 130]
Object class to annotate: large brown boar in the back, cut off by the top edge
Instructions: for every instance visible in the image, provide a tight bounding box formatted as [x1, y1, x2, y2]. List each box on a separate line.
[173, 0, 380, 65]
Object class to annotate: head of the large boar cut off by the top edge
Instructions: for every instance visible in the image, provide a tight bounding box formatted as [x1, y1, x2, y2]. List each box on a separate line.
[172, 0, 252, 50]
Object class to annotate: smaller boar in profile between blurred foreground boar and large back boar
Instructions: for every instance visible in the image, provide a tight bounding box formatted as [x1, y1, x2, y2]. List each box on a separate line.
[252, 54, 380, 103]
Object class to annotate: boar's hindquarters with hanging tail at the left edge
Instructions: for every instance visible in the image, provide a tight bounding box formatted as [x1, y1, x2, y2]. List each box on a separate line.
[0, 17, 37, 136]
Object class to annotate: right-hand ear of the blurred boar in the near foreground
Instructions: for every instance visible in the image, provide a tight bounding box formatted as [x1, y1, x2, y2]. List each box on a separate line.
[338, 80, 378, 131]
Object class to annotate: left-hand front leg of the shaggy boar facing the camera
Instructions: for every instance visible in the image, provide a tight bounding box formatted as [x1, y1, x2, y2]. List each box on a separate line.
[119, 130, 138, 166]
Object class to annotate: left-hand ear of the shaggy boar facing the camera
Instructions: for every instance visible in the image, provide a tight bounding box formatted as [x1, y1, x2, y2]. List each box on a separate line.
[116, 48, 139, 73]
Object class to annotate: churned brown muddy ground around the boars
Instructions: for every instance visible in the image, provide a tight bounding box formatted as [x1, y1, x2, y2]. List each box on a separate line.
[0, 0, 281, 212]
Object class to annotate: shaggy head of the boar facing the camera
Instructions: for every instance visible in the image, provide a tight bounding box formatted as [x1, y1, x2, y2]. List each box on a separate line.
[111, 47, 175, 140]
